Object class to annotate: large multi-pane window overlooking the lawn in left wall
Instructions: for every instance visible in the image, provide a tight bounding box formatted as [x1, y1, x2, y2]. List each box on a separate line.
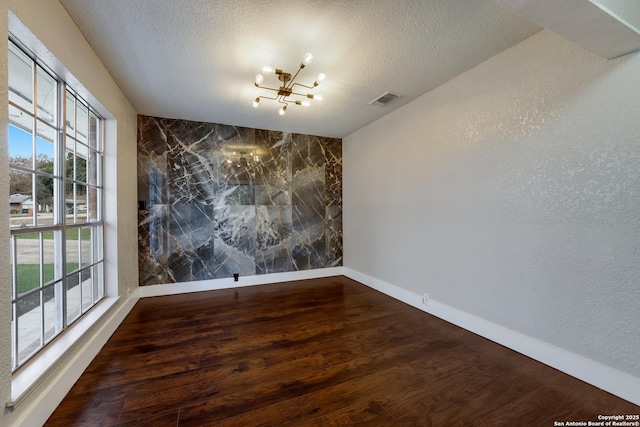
[9, 41, 104, 370]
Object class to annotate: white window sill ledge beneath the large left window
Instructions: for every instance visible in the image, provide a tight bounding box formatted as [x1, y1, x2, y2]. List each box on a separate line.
[11, 297, 120, 404]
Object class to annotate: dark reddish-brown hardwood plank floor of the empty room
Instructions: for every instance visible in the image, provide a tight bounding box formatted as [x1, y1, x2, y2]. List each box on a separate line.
[46, 277, 640, 427]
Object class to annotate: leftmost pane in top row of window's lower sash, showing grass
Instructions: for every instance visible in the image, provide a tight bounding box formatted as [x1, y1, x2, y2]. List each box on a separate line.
[15, 233, 40, 295]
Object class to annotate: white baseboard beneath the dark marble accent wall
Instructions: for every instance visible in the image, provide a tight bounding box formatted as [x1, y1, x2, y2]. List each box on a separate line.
[138, 267, 344, 298]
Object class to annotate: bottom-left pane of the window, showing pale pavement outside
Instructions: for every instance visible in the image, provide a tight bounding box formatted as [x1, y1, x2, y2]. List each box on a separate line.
[16, 292, 42, 363]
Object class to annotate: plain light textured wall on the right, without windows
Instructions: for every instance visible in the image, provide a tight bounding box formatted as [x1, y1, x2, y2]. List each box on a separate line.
[343, 30, 640, 376]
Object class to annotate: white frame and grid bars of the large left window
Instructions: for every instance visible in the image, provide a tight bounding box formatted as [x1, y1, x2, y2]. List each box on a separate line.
[9, 38, 106, 373]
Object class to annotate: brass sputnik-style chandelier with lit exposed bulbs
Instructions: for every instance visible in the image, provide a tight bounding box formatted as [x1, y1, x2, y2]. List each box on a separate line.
[253, 53, 326, 116]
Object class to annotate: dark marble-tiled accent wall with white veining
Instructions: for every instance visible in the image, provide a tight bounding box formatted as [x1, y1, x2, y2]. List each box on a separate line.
[138, 116, 342, 286]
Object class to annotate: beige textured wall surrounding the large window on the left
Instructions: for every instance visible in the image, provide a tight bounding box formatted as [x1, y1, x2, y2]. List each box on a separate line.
[0, 0, 138, 425]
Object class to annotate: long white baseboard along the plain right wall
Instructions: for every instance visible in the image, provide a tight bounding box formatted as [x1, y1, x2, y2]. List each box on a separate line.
[344, 267, 640, 405]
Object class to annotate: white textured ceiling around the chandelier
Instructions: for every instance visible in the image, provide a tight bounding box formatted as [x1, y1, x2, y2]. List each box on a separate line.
[60, 0, 540, 137]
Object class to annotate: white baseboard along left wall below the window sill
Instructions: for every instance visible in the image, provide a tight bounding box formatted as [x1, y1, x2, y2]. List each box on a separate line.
[9, 290, 139, 427]
